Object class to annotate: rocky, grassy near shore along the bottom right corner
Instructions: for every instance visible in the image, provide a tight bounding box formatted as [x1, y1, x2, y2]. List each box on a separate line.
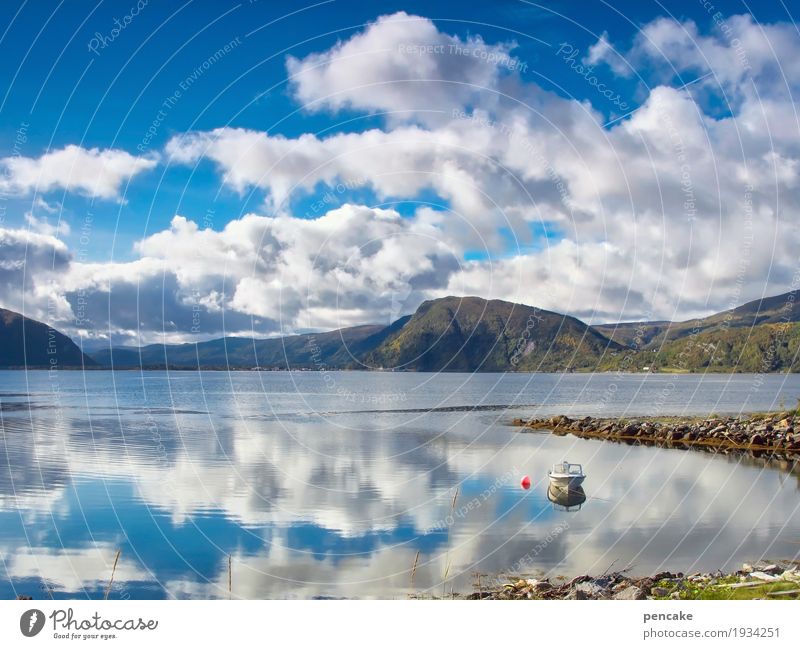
[466, 561, 800, 600]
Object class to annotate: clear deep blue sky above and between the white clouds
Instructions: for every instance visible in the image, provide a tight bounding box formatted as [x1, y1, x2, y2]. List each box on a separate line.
[0, 0, 781, 253]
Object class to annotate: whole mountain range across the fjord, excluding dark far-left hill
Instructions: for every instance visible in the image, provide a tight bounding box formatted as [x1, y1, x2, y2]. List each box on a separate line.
[87, 291, 800, 372]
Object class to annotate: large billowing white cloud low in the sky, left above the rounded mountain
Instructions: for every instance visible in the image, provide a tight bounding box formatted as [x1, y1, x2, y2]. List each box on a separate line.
[129, 205, 459, 331]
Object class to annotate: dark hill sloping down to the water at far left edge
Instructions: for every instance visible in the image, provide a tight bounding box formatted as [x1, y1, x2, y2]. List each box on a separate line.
[0, 309, 96, 369]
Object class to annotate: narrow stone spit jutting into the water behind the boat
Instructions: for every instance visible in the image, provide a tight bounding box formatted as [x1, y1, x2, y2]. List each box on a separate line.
[513, 411, 800, 460]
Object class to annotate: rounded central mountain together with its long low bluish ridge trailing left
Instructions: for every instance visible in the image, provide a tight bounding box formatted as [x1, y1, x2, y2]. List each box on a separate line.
[93, 297, 624, 372]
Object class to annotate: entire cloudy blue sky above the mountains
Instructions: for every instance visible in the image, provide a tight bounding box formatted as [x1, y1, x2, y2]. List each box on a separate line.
[0, 0, 800, 346]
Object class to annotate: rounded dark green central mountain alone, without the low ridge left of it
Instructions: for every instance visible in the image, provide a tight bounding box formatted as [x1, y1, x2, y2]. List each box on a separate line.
[365, 297, 623, 372]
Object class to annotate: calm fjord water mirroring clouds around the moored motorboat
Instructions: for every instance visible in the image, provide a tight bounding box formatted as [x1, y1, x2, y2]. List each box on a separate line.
[0, 371, 800, 599]
